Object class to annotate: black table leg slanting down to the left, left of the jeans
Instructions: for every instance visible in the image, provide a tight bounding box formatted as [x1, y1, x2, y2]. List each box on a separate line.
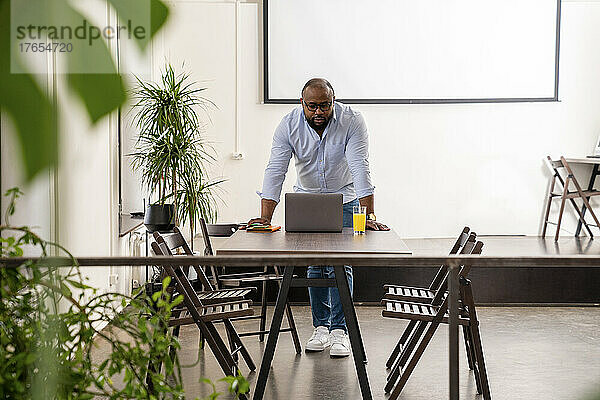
[252, 267, 294, 400]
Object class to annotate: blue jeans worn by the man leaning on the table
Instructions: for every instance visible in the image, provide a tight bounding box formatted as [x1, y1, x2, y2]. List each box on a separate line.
[306, 199, 359, 332]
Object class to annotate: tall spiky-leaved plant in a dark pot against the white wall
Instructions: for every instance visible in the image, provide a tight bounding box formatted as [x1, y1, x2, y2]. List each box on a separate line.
[130, 64, 223, 242]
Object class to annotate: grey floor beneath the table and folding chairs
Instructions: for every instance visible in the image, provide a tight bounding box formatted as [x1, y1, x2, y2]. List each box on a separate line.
[170, 306, 600, 400]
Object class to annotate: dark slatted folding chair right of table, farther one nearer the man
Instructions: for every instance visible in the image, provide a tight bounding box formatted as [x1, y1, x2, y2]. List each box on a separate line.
[383, 227, 475, 368]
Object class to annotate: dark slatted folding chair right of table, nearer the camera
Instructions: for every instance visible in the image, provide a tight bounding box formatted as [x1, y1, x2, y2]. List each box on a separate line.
[382, 242, 491, 400]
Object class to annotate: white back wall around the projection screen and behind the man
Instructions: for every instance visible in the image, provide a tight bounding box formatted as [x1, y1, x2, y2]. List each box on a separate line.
[118, 0, 600, 237]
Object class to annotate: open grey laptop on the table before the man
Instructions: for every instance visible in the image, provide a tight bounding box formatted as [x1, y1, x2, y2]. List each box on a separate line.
[285, 193, 344, 232]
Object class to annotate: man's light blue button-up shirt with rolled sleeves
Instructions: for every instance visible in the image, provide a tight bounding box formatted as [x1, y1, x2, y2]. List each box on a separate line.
[260, 103, 375, 203]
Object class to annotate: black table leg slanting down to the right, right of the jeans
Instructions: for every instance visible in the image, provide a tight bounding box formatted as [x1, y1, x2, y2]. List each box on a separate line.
[334, 265, 373, 400]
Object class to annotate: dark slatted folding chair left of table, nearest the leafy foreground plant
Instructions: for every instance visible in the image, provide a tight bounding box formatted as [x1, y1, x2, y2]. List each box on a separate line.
[152, 236, 256, 375]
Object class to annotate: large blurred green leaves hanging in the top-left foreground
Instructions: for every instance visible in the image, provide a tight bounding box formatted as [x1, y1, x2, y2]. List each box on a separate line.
[0, 0, 169, 180]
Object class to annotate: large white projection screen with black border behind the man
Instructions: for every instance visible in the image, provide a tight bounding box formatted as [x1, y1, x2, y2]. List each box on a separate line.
[263, 0, 560, 103]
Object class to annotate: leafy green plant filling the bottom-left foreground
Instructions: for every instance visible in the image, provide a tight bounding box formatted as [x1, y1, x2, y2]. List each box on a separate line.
[0, 189, 249, 399]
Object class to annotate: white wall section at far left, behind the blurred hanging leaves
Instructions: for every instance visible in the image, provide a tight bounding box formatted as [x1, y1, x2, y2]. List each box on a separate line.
[57, 6, 130, 294]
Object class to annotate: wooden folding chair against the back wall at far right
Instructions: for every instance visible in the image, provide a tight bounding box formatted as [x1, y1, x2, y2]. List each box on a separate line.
[542, 156, 600, 241]
